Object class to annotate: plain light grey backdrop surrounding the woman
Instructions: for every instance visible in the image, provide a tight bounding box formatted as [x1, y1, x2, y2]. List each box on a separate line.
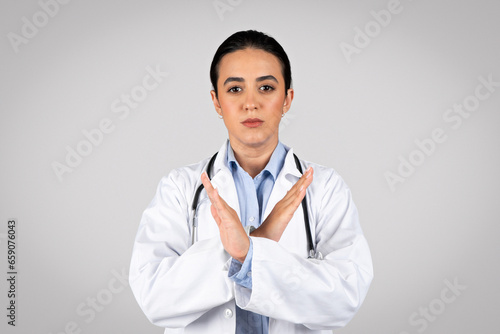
[0, 0, 500, 334]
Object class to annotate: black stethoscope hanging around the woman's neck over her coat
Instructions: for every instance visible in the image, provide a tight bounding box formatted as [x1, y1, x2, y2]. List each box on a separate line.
[191, 153, 323, 260]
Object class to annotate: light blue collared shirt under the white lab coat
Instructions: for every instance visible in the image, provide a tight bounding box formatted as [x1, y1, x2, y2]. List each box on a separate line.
[225, 142, 287, 334]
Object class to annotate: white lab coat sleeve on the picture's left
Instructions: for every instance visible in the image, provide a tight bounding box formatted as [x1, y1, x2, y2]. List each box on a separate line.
[129, 170, 234, 328]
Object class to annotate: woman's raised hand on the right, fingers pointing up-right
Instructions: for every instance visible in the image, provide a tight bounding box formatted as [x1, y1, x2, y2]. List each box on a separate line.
[254, 167, 313, 242]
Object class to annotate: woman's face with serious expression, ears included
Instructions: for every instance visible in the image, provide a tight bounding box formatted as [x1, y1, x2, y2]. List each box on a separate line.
[211, 49, 293, 148]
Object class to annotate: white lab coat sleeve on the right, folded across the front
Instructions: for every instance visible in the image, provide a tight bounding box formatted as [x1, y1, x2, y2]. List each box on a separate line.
[235, 167, 373, 330]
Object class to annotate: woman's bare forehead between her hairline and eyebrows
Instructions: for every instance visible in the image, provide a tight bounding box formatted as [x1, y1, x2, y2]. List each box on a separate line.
[219, 49, 283, 82]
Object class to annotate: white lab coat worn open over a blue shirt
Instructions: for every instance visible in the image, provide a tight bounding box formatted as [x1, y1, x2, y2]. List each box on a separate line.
[130, 142, 373, 334]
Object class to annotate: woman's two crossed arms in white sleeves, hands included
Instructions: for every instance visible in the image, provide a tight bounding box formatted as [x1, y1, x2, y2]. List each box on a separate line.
[130, 167, 373, 332]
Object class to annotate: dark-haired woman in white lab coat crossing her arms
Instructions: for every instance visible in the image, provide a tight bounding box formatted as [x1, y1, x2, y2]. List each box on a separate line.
[130, 31, 373, 334]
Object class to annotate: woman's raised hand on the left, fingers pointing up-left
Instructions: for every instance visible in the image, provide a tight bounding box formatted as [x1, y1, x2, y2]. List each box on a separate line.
[201, 172, 250, 263]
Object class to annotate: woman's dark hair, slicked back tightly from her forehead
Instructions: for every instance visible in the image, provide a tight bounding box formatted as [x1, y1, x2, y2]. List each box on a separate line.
[210, 30, 292, 96]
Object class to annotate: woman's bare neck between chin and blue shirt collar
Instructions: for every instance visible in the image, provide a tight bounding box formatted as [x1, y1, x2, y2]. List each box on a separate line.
[230, 139, 278, 178]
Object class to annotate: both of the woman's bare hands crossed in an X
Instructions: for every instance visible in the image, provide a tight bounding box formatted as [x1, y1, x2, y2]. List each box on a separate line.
[201, 167, 313, 262]
